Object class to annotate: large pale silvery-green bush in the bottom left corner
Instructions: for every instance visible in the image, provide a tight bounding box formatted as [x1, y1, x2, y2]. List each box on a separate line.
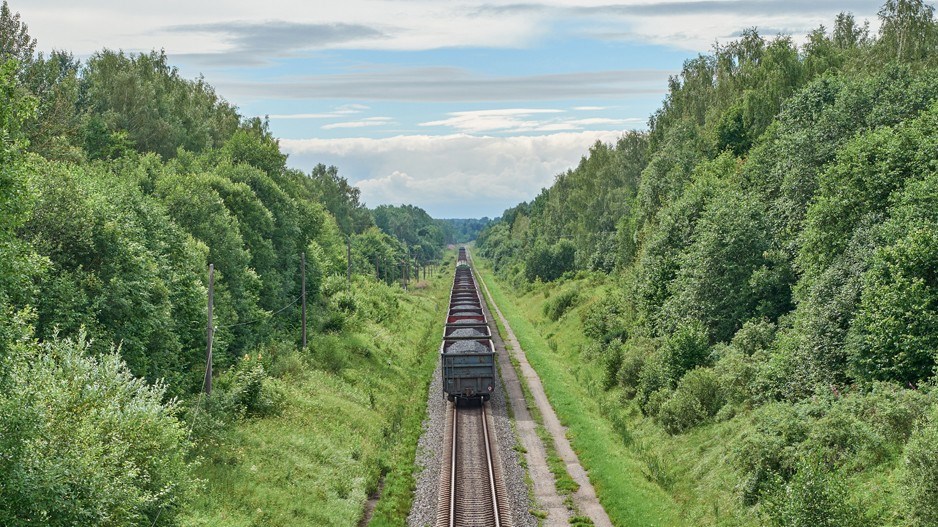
[0, 334, 195, 527]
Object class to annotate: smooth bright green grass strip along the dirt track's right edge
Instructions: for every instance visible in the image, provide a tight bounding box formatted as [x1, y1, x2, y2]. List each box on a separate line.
[477, 260, 684, 526]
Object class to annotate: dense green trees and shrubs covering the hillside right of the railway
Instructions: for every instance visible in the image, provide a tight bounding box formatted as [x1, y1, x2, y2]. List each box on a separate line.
[479, 0, 938, 525]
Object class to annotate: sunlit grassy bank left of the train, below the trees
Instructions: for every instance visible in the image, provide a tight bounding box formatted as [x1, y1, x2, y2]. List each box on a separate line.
[183, 276, 449, 526]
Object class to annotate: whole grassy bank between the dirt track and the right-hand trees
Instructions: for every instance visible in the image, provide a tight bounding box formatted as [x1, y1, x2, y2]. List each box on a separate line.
[477, 259, 902, 526]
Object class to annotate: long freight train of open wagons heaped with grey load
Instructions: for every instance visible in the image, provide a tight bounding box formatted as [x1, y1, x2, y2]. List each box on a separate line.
[440, 247, 496, 402]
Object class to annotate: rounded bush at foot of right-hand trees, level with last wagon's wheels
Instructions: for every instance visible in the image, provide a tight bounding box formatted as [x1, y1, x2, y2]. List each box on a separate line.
[658, 368, 725, 434]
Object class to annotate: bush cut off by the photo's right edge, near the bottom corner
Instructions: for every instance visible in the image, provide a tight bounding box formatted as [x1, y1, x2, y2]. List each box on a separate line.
[900, 406, 938, 527]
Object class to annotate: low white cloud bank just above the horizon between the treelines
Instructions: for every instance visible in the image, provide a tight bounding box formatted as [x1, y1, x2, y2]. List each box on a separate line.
[280, 131, 622, 218]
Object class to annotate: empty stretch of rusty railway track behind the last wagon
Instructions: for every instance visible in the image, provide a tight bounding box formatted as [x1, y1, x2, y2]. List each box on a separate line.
[436, 399, 511, 527]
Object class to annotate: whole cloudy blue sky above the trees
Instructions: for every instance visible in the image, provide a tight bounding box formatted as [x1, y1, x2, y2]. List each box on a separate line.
[18, 0, 882, 218]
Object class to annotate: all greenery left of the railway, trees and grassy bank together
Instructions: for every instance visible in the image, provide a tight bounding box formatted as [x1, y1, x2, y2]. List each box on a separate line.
[0, 1, 445, 527]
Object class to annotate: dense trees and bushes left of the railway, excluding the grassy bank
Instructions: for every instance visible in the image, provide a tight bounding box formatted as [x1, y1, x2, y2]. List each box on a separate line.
[0, 2, 444, 527]
